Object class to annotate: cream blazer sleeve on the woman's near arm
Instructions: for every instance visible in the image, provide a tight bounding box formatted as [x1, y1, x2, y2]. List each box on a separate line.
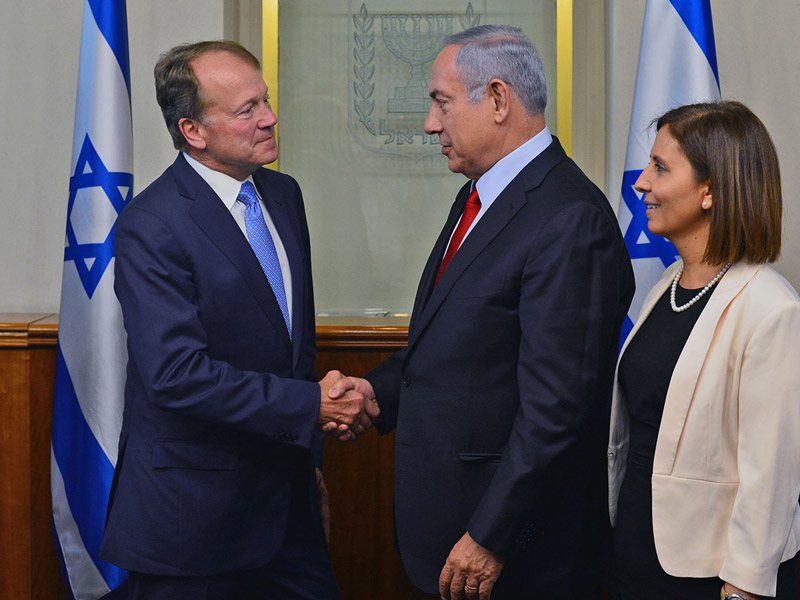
[720, 301, 800, 596]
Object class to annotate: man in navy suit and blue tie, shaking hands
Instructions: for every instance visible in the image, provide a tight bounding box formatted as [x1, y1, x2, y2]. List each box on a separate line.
[101, 42, 377, 600]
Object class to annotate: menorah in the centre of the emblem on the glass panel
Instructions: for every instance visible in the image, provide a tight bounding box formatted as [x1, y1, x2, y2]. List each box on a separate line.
[381, 14, 453, 113]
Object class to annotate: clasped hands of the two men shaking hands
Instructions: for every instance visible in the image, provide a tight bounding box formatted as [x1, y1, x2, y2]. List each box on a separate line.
[317, 371, 381, 442]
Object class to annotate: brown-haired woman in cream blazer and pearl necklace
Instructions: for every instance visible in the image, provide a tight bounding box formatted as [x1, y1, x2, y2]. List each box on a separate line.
[608, 102, 800, 600]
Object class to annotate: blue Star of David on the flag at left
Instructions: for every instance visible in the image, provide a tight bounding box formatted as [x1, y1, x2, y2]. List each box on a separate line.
[64, 134, 133, 298]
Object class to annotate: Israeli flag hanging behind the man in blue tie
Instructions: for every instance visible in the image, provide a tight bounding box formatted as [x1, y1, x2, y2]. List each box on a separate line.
[50, 0, 133, 600]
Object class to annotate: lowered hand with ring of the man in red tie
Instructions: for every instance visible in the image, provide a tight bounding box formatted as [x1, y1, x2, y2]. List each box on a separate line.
[439, 533, 503, 600]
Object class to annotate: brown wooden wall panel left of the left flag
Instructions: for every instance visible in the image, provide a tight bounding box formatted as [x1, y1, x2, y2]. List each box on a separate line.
[0, 314, 67, 600]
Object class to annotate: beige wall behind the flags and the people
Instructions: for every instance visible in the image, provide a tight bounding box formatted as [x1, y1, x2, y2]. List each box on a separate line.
[0, 0, 800, 312]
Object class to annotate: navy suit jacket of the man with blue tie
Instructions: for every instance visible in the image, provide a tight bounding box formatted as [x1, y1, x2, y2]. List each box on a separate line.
[101, 156, 322, 575]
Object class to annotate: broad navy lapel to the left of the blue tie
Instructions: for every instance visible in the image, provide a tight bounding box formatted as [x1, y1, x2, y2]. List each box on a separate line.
[173, 155, 290, 356]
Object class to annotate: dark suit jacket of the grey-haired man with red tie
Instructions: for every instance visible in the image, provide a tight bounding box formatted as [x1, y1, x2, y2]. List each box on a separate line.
[367, 140, 634, 598]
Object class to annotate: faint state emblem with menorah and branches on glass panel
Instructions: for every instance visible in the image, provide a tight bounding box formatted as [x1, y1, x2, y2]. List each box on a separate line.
[349, 2, 481, 160]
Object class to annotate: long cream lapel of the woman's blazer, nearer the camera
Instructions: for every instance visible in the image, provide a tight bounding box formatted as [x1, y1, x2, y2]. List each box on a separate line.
[652, 263, 759, 473]
